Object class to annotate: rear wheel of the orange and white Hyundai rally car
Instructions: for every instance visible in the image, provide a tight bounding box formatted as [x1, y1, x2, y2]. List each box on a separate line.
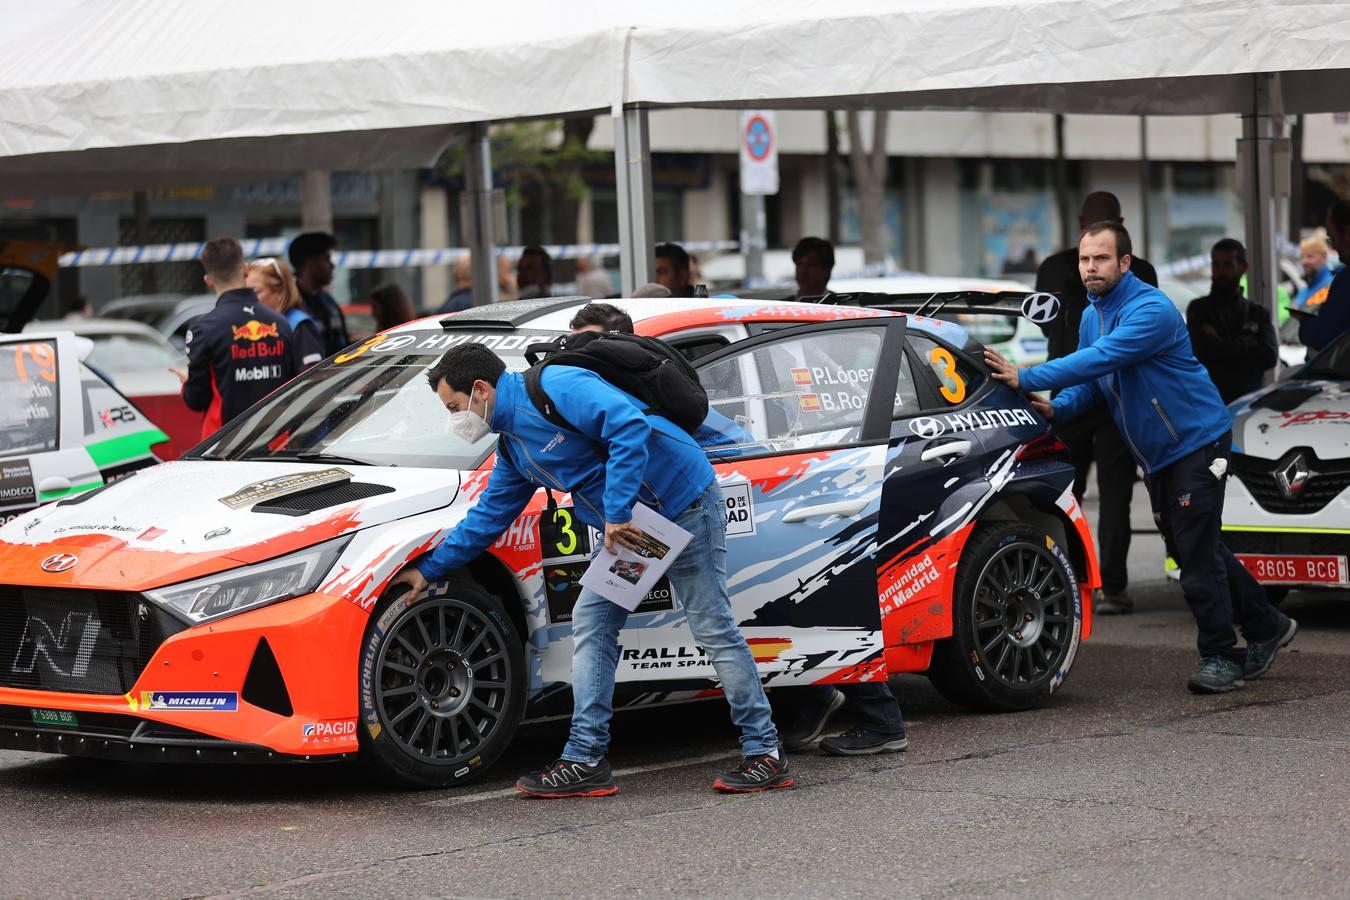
[929, 522, 1083, 711]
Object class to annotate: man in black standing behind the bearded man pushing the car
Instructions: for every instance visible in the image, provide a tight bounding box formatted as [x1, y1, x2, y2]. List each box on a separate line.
[1035, 190, 1158, 615]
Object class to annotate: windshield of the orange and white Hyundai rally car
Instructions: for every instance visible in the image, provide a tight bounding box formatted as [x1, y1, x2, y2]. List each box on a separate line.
[188, 329, 559, 470]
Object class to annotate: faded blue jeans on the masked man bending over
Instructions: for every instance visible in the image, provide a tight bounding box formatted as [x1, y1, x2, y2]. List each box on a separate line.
[563, 482, 778, 765]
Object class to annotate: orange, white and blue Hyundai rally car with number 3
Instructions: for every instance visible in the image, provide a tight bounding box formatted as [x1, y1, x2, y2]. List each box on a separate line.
[0, 292, 1098, 785]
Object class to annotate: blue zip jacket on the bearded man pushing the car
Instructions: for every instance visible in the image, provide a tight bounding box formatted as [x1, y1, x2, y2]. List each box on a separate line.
[1019, 273, 1233, 474]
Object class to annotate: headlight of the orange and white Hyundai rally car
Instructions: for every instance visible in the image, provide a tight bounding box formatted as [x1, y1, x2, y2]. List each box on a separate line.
[146, 534, 352, 625]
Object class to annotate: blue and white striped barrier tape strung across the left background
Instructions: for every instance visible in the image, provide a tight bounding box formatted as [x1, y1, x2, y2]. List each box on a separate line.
[61, 237, 740, 269]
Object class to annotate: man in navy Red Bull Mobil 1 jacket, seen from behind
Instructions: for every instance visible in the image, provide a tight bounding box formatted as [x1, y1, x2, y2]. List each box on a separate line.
[180, 237, 296, 439]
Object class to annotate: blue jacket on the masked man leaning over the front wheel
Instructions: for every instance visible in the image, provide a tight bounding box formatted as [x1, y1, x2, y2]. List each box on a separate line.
[417, 366, 714, 582]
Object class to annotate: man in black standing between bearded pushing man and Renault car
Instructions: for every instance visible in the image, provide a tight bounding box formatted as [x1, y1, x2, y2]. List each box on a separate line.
[1185, 237, 1280, 403]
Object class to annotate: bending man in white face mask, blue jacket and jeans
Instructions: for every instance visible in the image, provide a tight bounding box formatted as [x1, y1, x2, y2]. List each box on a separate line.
[390, 344, 792, 797]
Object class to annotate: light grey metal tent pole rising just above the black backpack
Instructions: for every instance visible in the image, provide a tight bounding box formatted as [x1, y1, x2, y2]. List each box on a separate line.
[614, 109, 656, 297]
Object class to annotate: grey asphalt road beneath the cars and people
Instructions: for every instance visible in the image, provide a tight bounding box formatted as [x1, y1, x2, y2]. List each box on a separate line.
[0, 493, 1350, 899]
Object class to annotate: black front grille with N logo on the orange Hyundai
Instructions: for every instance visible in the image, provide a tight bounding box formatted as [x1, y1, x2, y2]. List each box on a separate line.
[0, 586, 186, 694]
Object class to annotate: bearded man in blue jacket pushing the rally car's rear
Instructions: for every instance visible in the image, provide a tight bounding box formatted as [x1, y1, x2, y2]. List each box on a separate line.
[984, 221, 1299, 694]
